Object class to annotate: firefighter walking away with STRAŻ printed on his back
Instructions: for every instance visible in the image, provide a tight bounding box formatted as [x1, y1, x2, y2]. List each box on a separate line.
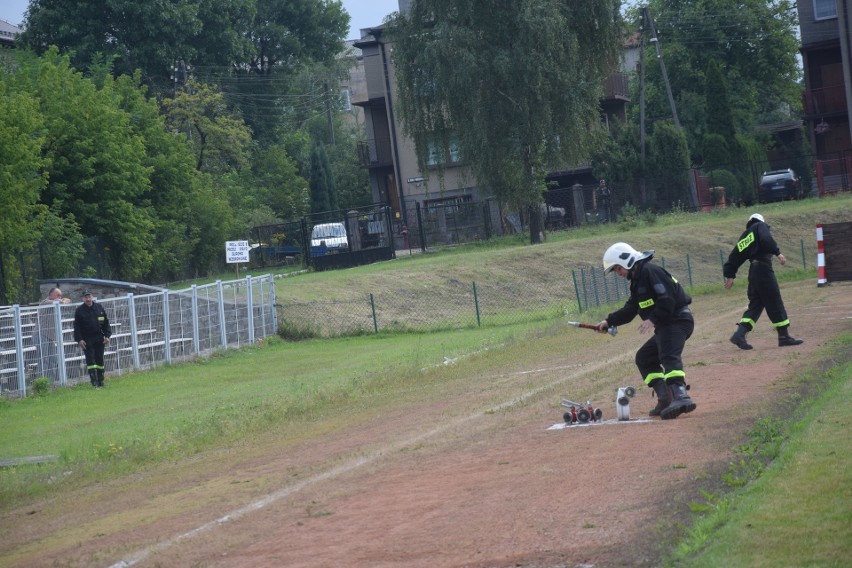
[722, 213, 802, 350]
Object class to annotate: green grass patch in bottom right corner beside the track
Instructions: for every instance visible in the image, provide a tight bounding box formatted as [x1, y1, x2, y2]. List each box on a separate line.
[667, 334, 852, 568]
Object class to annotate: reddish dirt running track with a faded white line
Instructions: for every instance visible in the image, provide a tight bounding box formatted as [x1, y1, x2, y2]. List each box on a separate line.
[0, 282, 852, 568]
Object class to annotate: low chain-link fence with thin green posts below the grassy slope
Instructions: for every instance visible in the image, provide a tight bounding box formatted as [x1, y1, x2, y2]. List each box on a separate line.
[278, 241, 816, 339]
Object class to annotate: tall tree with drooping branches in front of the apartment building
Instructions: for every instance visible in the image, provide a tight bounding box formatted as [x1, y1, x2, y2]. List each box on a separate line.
[389, 0, 620, 242]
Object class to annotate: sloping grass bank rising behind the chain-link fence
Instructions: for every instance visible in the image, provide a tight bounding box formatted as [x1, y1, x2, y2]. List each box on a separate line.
[268, 194, 852, 303]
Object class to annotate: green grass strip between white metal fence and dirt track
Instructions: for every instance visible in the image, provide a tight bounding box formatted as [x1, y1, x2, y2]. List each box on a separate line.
[0, 324, 540, 503]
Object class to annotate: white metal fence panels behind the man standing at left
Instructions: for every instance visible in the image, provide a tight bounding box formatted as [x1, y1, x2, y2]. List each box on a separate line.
[0, 275, 278, 397]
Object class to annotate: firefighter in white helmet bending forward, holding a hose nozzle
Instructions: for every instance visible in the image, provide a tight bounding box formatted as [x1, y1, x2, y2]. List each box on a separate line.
[597, 243, 696, 420]
